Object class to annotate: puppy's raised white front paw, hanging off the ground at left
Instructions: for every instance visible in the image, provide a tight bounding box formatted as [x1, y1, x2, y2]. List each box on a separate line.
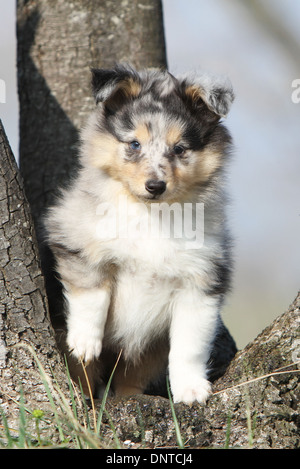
[67, 329, 102, 364]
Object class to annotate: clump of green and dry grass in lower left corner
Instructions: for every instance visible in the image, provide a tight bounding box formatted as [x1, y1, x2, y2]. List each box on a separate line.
[0, 346, 121, 449]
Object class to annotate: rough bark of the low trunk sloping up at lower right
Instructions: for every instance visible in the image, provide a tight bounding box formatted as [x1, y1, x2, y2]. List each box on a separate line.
[99, 292, 300, 449]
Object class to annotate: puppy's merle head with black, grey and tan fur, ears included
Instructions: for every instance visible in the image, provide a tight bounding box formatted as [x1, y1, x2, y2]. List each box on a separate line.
[83, 66, 233, 202]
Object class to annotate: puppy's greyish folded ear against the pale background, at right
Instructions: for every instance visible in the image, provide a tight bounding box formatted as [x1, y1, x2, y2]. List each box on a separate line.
[182, 75, 234, 119]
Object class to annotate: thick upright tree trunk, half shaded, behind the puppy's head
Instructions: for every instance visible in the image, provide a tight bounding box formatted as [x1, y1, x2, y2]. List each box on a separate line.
[17, 0, 166, 227]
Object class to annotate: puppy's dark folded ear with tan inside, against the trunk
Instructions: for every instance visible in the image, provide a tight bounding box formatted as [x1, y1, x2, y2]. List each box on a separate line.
[92, 66, 141, 112]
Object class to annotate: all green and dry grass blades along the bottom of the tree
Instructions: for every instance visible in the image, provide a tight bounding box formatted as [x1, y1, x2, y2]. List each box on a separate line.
[0, 345, 299, 449]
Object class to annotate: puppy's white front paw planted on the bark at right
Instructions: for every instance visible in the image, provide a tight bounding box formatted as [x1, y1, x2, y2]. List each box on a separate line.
[171, 377, 211, 404]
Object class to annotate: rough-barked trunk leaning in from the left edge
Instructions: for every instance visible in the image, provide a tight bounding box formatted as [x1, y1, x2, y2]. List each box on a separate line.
[0, 121, 68, 438]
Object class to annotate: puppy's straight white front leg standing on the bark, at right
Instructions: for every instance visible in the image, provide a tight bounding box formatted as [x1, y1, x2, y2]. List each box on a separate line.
[169, 288, 218, 403]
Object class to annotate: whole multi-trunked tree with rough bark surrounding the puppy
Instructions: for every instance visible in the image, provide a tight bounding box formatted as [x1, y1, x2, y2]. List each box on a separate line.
[0, 0, 300, 448]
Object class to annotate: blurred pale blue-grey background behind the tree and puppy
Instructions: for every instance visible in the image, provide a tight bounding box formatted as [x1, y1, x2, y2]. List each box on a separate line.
[0, 0, 300, 348]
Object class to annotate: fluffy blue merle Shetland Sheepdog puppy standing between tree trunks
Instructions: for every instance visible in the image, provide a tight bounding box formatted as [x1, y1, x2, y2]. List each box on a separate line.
[45, 65, 237, 403]
